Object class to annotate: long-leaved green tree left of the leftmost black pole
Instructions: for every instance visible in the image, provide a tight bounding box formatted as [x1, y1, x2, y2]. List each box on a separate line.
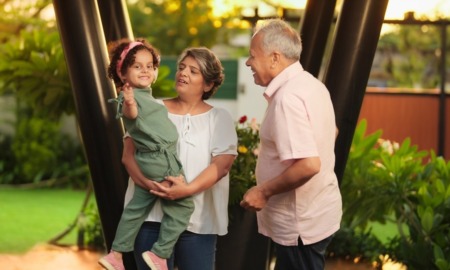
[0, 28, 75, 120]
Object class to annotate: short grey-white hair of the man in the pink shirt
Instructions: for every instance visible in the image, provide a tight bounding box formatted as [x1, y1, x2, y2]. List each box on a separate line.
[253, 19, 302, 61]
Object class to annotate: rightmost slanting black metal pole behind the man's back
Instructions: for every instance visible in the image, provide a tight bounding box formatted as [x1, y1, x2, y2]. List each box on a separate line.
[324, 0, 389, 181]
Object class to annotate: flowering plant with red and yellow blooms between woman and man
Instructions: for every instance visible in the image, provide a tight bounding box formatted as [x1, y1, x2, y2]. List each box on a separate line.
[229, 115, 259, 205]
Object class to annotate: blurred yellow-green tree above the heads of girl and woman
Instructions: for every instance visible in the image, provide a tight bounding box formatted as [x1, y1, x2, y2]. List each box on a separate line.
[128, 0, 227, 55]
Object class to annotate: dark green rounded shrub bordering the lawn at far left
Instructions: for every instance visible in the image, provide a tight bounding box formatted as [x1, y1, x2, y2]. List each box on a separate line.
[0, 117, 89, 188]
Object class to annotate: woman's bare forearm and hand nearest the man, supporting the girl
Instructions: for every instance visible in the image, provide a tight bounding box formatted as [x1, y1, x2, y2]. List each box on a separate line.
[150, 154, 236, 200]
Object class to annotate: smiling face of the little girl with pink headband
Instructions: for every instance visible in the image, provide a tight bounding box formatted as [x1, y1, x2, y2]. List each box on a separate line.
[122, 50, 155, 88]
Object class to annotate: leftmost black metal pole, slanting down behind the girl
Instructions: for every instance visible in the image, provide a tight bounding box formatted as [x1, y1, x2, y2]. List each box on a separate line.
[53, 0, 128, 254]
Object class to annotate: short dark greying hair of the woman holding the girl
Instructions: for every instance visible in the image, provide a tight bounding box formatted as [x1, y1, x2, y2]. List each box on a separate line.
[177, 47, 225, 100]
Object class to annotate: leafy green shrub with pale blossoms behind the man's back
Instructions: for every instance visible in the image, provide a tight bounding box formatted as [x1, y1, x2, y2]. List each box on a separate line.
[329, 120, 450, 270]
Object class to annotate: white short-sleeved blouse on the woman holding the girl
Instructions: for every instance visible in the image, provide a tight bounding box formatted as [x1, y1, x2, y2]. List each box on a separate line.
[125, 108, 237, 235]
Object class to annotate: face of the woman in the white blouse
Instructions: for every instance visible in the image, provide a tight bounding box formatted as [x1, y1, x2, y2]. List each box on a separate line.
[175, 56, 212, 99]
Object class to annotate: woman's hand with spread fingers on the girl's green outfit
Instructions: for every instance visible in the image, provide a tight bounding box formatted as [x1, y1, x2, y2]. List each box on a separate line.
[150, 175, 192, 200]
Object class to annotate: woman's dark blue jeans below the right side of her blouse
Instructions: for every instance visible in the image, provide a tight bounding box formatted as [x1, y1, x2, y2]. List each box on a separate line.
[175, 231, 217, 270]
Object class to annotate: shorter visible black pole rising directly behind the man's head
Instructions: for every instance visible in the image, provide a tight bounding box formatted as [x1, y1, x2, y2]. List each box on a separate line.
[300, 0, 336, 77]
